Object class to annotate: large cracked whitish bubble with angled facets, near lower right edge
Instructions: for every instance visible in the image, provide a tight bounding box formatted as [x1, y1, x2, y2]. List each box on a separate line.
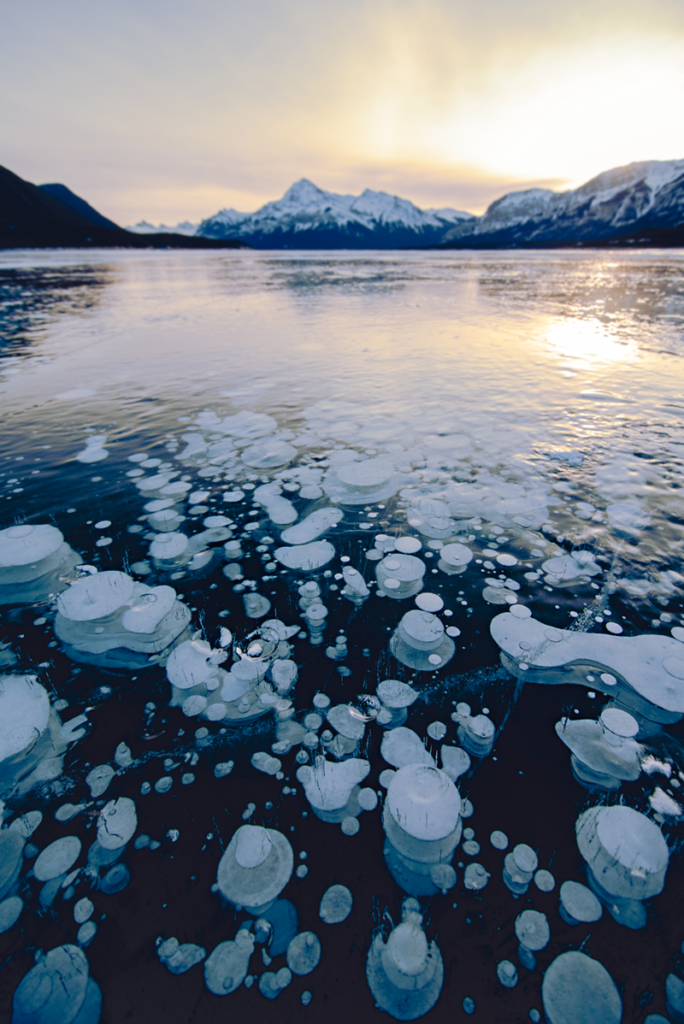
[575, 805, 670, 900]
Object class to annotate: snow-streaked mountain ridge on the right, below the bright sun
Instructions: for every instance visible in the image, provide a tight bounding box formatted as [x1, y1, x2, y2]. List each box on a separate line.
[444, 160, 684, 249]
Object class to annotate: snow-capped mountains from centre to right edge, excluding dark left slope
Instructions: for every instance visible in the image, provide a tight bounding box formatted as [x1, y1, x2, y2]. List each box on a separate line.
[132, 160, 684, 249]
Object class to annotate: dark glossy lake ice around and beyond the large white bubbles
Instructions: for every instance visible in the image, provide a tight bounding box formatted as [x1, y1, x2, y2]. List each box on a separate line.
[0, 251, 684, 1024]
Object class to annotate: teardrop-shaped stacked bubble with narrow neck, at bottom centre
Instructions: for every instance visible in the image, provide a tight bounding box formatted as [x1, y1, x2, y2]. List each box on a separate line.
[366, 898, 444, 1021]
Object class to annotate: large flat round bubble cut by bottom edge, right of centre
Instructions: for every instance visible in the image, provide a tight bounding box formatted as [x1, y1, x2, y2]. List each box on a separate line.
[542, 950, 623, 1024]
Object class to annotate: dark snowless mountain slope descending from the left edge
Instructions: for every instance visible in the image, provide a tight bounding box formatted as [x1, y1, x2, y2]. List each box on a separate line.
[0, 167, 244, 249]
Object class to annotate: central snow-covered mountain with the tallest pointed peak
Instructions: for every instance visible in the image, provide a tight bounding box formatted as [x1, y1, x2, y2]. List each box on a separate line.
[197, 178, 475, 249]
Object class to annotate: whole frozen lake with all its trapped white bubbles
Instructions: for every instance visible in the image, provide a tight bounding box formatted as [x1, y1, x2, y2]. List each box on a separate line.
[0, 250, 684, 1024]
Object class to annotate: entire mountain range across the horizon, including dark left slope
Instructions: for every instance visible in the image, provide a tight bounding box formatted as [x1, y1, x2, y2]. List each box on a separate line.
[0, 160, 684, 250]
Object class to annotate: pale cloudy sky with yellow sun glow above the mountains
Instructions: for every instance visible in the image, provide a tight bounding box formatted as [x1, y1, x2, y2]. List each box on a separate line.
[0, 0, 684, 224]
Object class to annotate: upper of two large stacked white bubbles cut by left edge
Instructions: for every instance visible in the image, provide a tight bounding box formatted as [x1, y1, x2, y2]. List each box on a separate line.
[0, 523, 81, 605]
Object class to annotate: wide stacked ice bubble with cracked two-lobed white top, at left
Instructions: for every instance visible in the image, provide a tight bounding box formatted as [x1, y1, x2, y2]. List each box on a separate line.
[54, 573, 190, 670]
